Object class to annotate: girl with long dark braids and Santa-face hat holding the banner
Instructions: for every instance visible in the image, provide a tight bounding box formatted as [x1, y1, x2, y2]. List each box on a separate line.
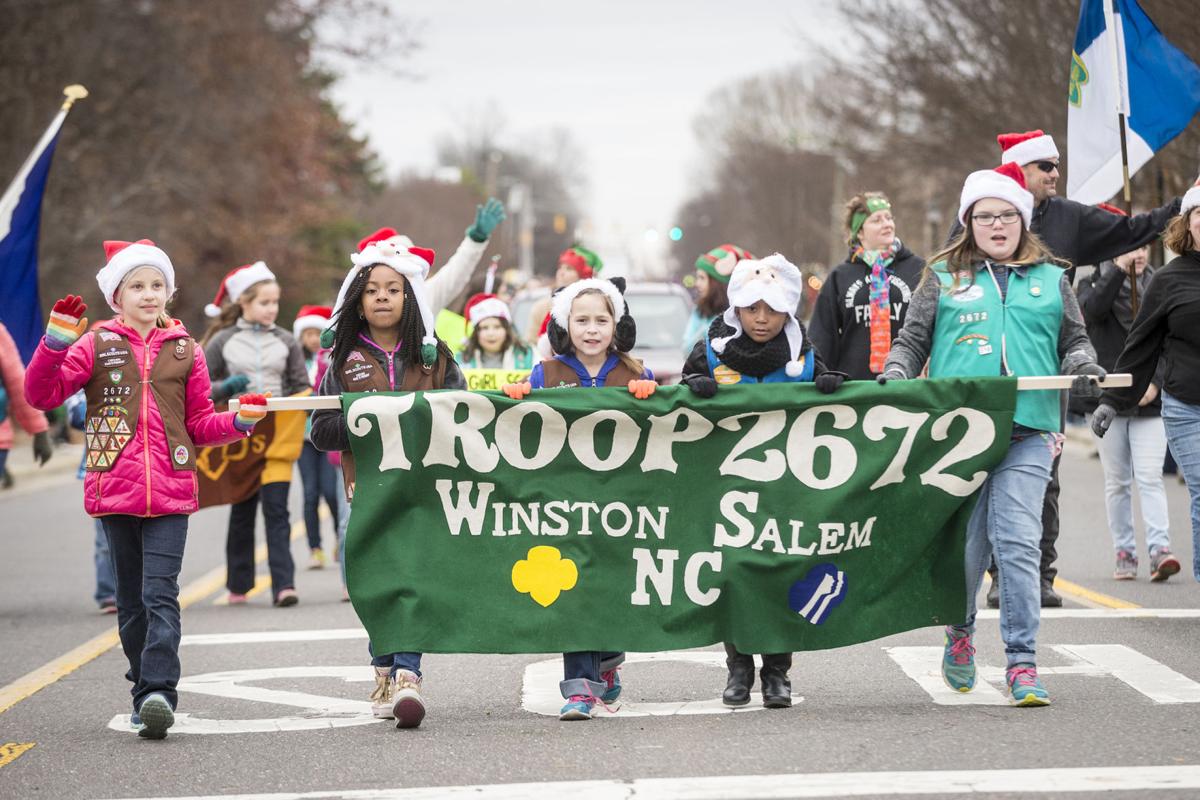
[310, 228, 467, 728]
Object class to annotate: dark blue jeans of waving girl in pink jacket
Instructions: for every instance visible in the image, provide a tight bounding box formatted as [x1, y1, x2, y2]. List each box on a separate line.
[101, 513, 187, 711]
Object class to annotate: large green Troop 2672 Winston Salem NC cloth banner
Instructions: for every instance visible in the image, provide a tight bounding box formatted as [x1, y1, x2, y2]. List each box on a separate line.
[342, 378, 1016, 652]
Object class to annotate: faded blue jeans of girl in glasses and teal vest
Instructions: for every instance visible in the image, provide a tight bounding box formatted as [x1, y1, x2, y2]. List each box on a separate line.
[954, 433, 1054, 667]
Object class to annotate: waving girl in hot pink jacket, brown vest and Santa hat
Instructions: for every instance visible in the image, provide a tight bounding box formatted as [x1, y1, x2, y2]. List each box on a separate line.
[25, 239, 266, 739]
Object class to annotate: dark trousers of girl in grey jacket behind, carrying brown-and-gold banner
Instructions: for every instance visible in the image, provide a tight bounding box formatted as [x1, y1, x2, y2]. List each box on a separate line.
[226, 481, 295, 597]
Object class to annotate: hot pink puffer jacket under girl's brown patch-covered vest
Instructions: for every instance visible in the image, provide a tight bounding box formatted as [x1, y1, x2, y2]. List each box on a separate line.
[25, 319, 245, 517]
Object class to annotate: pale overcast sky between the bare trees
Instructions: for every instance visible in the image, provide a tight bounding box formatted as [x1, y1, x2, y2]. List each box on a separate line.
[334, 0, 842, 250]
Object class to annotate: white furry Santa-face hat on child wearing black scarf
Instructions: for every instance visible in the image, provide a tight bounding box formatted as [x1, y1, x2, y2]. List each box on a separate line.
[712, 253, 804, 378]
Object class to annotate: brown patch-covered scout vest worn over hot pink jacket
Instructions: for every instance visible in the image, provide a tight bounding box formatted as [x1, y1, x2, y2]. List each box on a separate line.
[84, 329, 196, 473]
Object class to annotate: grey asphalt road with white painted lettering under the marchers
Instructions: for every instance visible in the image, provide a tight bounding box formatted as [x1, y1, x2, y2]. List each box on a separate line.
[0, 434, 1200, 799]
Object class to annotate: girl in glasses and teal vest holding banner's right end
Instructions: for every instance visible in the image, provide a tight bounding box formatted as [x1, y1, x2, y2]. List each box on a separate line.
[878, 164, 1105, 706]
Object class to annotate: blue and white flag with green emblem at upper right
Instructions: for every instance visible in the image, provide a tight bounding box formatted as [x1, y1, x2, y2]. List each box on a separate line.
[1067, 0, 1200, 204]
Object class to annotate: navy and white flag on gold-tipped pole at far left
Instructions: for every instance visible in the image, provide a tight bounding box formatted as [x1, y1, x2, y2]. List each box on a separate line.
[0, 85, 88, 363]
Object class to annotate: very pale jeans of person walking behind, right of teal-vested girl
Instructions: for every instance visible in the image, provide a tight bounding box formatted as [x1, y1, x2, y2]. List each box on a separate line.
[1096, 416, 1171, 554]
